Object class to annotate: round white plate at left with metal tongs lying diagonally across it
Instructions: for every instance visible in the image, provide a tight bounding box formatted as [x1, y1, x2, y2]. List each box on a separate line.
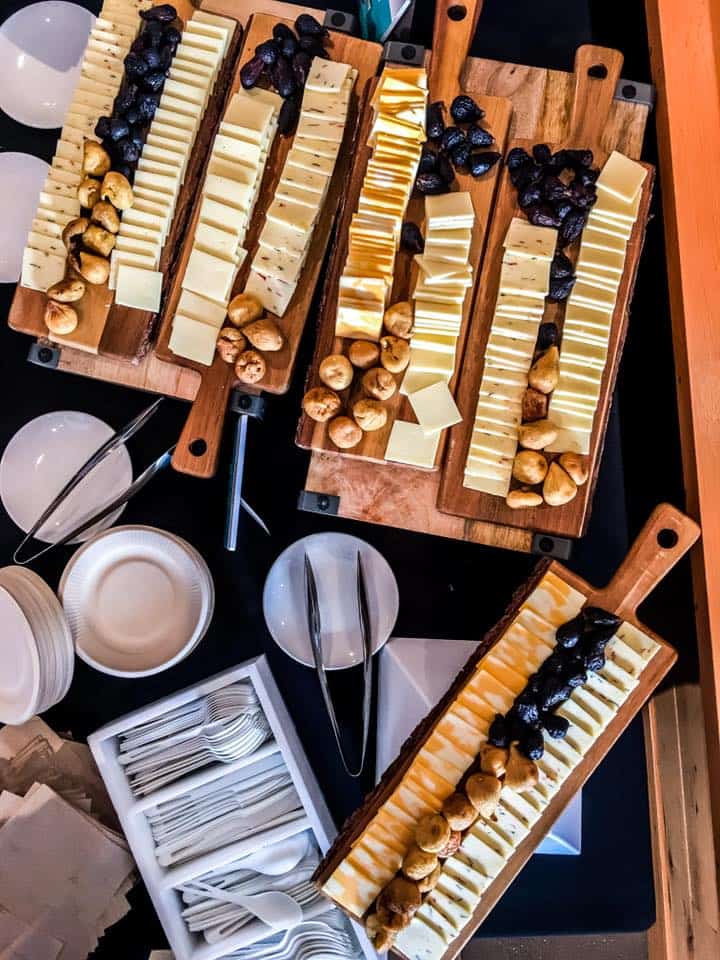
[0, 410, 132, 543]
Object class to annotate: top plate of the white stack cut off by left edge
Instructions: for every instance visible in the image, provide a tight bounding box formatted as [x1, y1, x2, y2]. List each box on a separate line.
[0, 587, 41, 724]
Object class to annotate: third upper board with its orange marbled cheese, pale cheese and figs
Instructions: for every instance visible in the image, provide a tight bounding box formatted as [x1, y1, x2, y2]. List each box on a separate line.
[297, 3, 511, 470]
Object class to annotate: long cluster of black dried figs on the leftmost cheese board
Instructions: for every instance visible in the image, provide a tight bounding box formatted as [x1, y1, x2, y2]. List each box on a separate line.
[95, 3, 181, 181]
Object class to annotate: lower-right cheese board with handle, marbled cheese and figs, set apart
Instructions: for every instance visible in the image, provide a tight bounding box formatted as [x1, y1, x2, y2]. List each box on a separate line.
[315, 504, 700, 960]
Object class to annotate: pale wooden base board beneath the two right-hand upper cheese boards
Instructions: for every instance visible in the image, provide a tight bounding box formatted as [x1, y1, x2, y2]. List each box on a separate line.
[305, 47, 649, 552]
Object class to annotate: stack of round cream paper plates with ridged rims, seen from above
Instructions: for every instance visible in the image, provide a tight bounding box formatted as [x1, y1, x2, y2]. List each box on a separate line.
[58, 526, 214, 677]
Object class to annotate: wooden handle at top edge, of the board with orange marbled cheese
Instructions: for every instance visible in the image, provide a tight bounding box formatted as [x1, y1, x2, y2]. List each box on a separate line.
[430, 0, 482, 101]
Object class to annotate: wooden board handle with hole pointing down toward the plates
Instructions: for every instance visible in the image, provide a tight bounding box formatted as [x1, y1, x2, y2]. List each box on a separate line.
[172, 357, 232, 479]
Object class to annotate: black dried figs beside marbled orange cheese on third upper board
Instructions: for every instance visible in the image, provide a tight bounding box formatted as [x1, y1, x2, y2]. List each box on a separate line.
[415, 94, 500, 194]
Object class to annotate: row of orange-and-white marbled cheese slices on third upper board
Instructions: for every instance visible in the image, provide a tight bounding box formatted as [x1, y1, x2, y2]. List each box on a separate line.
[335, 67, 427, 340]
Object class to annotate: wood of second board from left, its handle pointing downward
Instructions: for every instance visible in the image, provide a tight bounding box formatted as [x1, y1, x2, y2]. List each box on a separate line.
[155, 14, 381, 477]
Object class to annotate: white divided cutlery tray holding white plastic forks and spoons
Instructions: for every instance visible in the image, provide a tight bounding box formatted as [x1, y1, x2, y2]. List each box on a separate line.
[88, 656, 377, 960]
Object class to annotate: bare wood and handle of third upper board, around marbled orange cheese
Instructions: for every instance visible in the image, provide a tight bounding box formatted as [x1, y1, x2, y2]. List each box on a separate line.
[297, 0, 512, 468]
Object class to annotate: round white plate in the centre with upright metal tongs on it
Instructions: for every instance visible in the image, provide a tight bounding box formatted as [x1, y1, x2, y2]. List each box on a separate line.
[263, 533, 399, 670]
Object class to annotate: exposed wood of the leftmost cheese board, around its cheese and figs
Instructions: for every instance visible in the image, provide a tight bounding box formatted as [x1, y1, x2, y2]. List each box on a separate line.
[8, 0, 243, 361]
